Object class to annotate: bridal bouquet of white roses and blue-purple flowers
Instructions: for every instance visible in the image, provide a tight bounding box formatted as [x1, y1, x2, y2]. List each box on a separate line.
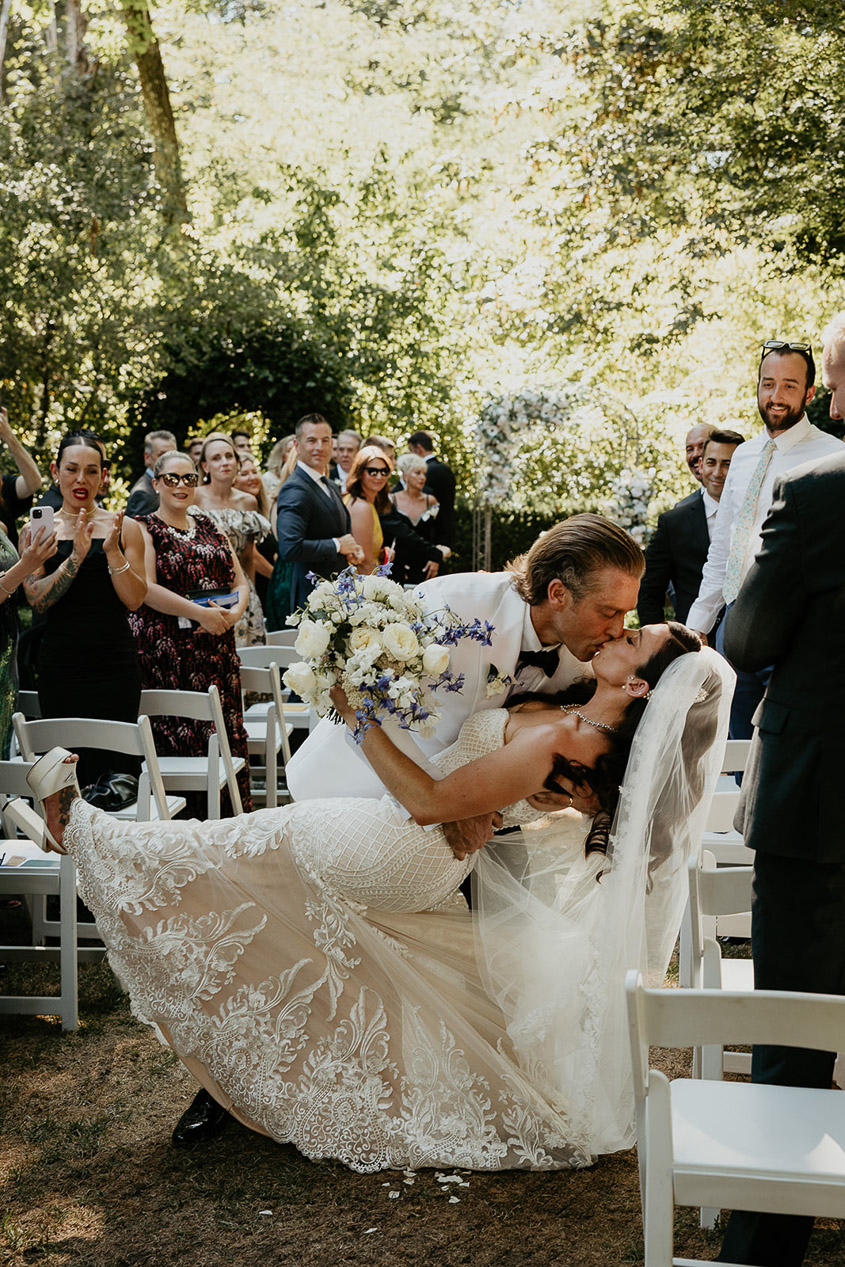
[284, 565, 493, 741]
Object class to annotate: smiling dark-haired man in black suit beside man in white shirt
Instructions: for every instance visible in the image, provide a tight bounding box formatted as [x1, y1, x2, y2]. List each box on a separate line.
[637, 431, 744, 625]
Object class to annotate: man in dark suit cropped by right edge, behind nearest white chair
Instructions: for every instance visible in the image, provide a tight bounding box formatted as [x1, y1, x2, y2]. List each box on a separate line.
[721, 313, 845, 1267]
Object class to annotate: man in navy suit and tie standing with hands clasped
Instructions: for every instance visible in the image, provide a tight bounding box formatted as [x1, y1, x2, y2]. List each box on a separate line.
[276, 413, 364, 609]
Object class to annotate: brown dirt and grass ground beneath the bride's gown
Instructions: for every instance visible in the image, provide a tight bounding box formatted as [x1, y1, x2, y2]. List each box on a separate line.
[0, 937, 845, 1267]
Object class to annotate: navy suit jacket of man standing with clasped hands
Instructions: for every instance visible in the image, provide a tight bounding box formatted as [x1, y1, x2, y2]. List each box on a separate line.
[276, 466, 350, 611]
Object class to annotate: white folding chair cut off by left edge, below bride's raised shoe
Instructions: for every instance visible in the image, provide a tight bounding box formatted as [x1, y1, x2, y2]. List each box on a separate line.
[0, 795, 105, 1030]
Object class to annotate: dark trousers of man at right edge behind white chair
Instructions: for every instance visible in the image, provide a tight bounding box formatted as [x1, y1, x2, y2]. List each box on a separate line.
[718, 853, 845, 1267]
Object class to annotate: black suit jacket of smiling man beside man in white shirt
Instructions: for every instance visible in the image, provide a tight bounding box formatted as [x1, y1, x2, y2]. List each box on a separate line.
[637, 493, 709, 625]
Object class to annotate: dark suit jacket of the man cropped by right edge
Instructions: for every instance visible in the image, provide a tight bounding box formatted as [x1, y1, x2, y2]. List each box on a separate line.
[725, 454, 845, 864]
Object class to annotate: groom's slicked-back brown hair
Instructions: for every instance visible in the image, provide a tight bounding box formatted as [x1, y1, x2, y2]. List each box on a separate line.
[505, 514, 645, 607]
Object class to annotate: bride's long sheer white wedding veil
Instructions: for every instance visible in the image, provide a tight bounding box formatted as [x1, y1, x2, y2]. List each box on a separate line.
[474, 647, 735, 1157]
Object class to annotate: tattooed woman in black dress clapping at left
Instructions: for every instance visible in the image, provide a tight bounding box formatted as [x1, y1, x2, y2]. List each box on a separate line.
[22, 435, 147, 787]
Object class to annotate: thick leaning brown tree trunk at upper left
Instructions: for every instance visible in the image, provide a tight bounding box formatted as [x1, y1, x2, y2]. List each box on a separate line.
[120, 0, 189, 223]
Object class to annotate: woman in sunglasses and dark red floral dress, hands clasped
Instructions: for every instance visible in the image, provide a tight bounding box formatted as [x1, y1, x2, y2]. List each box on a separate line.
[130, 451, 252, 817]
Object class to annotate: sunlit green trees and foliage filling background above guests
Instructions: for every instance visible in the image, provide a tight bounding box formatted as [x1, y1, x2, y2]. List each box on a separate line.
[0, 0, 845, 534]
